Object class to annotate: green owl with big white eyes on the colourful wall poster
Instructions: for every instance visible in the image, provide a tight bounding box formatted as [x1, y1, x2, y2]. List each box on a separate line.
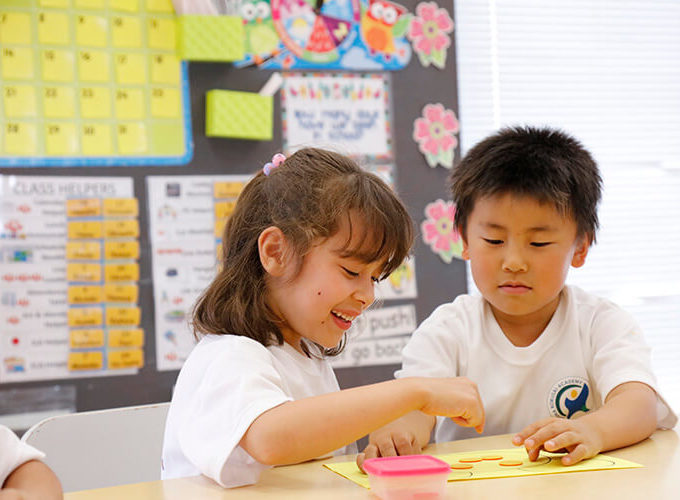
[239, 0, 279, 64]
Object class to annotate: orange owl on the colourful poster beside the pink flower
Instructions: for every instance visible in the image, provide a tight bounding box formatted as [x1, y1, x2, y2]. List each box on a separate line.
[361, 0, 410, 58]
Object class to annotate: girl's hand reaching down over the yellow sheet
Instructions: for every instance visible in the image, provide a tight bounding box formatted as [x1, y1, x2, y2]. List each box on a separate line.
[420, 377, 484, 433]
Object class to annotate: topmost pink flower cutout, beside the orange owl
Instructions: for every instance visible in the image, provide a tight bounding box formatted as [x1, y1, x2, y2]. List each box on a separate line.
[406, 2, 453, 68]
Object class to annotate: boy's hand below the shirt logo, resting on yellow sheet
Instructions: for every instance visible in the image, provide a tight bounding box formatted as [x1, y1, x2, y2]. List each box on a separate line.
[512, 418, 603, 465]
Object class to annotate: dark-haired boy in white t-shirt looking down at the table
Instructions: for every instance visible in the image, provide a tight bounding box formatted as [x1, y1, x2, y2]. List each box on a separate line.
[358, 127, 677, 465]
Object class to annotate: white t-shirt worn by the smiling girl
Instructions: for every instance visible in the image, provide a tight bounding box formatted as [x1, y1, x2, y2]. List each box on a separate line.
[161, 335, 356, 488]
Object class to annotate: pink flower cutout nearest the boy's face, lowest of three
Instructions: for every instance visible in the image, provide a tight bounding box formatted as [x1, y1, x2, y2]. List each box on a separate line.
[421, 200, 463, 263]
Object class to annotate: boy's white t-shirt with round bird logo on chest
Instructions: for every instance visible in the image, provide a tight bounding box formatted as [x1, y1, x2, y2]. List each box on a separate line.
[395, 286, 677, 442]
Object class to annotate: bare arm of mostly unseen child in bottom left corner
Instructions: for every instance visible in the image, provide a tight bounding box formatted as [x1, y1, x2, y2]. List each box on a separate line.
[0, 460, 63, 500]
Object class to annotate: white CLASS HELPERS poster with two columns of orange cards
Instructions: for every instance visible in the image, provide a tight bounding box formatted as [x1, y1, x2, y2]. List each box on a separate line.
[0, 175, 144, 382]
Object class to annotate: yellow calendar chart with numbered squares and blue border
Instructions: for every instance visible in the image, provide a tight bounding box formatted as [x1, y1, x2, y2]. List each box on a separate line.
[0, 0, 193, 167]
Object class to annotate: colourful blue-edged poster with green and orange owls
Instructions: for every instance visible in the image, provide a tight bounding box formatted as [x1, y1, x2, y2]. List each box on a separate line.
[234, 0, 412, 71]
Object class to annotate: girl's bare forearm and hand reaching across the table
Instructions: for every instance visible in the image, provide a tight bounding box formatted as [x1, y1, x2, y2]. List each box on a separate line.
[240, 377, 484, 465]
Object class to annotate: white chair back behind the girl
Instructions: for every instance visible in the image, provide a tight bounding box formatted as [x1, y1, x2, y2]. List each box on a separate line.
[22, 403, 170, 492]
